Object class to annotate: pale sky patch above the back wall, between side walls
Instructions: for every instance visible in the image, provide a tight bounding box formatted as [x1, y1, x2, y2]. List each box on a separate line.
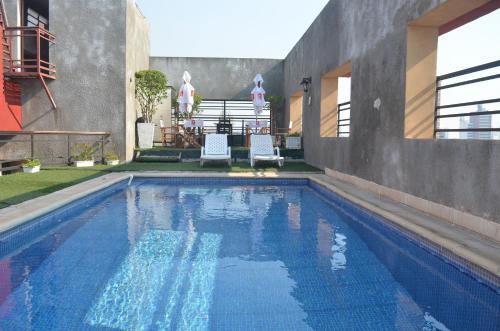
[136, 0, 328, 59]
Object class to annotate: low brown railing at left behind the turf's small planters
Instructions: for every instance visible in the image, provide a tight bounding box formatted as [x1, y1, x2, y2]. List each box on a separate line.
[0, 131, 111, 164]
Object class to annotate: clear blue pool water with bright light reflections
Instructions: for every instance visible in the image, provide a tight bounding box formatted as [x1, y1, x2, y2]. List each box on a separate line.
[0, 179, 500, 331]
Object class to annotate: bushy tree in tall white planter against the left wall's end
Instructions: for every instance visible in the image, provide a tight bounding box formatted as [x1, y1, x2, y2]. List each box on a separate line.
[135, 70, 168, 148]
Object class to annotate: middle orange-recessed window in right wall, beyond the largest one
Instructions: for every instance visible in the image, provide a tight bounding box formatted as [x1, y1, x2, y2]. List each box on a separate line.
[320, 62, 351, 138]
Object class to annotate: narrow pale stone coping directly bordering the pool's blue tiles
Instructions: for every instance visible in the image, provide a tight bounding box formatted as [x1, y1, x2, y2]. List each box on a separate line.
[0, 172, 500, 277]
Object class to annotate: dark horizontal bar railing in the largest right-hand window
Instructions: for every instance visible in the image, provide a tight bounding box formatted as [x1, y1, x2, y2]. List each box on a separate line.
[434, 61, 500, 138]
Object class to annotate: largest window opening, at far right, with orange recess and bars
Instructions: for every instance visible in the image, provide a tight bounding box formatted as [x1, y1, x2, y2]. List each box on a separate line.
[405, 0, 500, 139]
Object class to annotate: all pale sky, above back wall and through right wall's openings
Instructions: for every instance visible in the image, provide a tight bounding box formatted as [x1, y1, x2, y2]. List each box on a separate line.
[136, 0, 500, 138]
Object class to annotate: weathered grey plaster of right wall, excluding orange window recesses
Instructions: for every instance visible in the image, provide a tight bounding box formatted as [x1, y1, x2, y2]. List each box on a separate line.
[284, 0, 500, 222]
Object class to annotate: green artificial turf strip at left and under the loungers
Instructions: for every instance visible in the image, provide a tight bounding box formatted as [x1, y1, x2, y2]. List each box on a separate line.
[0, 162, 319, 208]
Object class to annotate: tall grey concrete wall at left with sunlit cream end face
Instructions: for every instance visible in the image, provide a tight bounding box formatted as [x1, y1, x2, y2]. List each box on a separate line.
[0, 0, 149, 162]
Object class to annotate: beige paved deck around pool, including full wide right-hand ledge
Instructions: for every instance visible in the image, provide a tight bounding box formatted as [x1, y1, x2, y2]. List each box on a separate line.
[0, 172, 500, 276]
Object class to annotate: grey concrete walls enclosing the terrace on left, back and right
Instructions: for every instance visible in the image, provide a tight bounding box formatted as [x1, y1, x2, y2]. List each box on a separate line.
[0, 0, 500, 227]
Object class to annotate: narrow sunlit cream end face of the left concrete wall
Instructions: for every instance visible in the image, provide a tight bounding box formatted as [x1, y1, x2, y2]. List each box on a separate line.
[125, 0, 150, 160]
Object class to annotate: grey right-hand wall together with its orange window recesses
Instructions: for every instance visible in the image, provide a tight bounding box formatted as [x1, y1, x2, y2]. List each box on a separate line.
[284, 0, 500, 222]
